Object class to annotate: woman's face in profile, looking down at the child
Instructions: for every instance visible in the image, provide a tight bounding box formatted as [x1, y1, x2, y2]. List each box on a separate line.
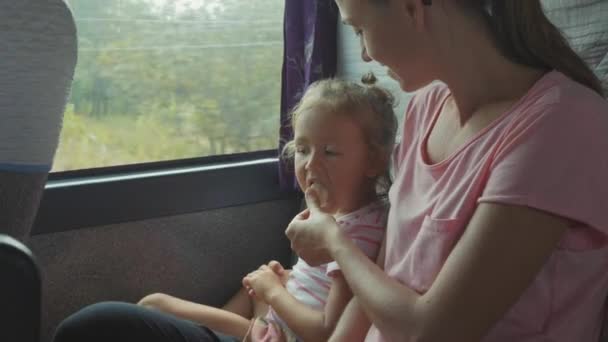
[336, 0, 433, 91]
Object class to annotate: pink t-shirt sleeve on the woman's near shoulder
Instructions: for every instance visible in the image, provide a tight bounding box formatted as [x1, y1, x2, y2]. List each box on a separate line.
[478, 101, 608, 235]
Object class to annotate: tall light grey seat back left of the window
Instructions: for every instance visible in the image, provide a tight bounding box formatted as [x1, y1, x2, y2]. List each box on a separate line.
[0, 0, 77, 240]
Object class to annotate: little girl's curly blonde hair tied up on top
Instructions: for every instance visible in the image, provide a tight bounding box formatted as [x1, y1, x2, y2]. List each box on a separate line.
[282, 73, 397, 196]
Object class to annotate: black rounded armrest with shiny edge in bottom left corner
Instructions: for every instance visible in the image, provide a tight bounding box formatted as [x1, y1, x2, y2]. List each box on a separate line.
[0, 235, 41, 342]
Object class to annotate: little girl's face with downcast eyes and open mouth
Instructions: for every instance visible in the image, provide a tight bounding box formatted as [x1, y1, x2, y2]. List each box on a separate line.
[294, 105, 379, 214]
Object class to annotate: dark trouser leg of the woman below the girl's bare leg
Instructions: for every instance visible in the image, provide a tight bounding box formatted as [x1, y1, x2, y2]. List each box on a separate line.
[53, 302, 239, 342]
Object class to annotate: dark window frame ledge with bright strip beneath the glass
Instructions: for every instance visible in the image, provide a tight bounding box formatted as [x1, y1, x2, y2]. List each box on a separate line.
[31, 150, 301, 235]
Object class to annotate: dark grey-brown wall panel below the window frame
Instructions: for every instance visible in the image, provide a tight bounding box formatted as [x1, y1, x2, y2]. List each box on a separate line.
[29, 196, 300, 342]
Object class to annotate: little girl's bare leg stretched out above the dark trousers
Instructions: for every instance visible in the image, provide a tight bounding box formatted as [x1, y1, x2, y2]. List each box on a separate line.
[137, 293, 250, 338]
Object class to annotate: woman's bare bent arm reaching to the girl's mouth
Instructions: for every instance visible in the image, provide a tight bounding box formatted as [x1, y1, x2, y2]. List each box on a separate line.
[288, 199, 569, 342]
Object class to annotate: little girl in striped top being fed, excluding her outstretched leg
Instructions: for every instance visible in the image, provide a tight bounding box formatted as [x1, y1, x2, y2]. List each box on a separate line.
[238, 75, 396, 341]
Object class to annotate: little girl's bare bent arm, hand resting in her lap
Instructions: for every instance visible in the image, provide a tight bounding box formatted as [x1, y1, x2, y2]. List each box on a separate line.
[250, 271, 352, 342]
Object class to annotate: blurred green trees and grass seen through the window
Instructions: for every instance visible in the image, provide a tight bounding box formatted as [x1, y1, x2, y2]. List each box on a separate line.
[53, 0, 284, 171]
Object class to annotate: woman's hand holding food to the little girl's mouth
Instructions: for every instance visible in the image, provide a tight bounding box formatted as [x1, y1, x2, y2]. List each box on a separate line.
[285, 184, 344, 266]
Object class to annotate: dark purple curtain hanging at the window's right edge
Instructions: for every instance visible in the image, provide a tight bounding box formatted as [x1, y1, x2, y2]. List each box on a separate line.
[279, 0, 338, 190]
